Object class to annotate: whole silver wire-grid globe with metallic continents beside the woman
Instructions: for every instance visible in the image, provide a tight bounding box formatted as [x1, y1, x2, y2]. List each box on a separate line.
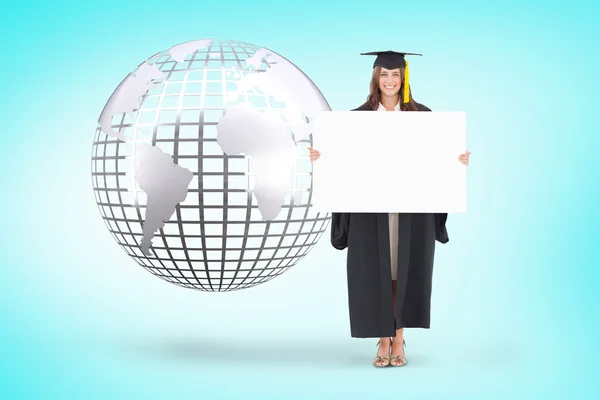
[91, 39, 330, 291]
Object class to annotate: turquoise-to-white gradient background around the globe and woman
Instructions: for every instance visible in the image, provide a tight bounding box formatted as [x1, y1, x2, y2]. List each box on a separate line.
[0, 0, 600, 400]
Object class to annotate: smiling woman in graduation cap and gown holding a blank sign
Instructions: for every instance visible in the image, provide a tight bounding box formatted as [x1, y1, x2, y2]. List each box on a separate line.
[309, 51, 471, 367]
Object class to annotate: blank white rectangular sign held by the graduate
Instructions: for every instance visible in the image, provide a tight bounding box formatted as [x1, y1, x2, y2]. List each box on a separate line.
[312, 111, 467, 213]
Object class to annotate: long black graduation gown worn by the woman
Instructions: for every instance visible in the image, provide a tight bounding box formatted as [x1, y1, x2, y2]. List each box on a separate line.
[331, 103, 448, 338]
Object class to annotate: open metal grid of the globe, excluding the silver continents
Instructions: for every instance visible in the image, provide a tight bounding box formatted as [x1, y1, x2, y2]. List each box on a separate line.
[91, 40, 330, 291]
